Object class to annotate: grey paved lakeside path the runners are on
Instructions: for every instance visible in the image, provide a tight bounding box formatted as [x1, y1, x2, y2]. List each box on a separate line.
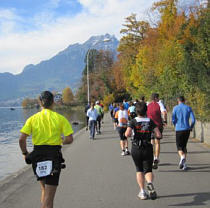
[0, 114, 210, 208]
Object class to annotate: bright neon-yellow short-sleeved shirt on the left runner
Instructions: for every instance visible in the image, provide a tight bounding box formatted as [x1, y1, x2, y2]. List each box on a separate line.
[20, 109, 74, 145]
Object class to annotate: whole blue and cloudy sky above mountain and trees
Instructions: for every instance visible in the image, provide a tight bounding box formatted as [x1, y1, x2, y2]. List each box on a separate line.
[0, 0, 203, 74]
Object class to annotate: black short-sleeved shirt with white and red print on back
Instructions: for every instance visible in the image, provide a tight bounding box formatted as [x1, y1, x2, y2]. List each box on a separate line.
[128, 117, 157, 142]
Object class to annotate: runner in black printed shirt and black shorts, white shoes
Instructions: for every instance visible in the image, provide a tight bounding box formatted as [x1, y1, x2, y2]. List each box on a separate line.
[125, 102, 161, 200]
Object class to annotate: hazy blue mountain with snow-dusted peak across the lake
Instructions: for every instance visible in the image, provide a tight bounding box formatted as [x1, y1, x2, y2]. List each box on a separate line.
[0, 34, 119, 101]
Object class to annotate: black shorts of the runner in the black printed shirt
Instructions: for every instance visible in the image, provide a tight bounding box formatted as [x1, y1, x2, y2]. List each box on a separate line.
[131, 144, 153, 173]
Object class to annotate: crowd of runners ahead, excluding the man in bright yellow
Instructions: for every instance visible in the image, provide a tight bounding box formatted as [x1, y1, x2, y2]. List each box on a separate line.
[85, 93, 195, 200]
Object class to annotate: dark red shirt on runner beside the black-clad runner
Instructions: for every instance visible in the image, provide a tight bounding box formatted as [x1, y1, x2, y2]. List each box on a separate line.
[147, 101, 163, 128]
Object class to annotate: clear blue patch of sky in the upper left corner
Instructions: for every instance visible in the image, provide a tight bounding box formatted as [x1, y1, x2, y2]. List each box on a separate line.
[0, 0, 82, 32]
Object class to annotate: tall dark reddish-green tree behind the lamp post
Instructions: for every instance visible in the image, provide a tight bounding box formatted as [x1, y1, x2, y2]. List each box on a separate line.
[76, 49, 114, 102]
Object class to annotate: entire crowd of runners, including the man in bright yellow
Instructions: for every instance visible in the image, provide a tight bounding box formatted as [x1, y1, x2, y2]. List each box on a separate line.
[19, 91, 195, 208]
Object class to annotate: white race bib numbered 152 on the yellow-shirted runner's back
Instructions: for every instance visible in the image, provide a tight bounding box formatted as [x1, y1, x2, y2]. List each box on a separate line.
[36, 160, 52, 177]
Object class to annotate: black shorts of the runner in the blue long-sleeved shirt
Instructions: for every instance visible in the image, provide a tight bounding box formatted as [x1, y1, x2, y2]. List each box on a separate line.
[176, 130, 190, 153]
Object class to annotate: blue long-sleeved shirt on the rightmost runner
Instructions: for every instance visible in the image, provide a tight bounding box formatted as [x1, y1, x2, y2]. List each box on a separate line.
[172, 103, 195, 131]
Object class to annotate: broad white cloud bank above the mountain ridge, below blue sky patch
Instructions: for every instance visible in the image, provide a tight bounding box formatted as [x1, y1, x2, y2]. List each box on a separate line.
[0, 0, 154, 73]
